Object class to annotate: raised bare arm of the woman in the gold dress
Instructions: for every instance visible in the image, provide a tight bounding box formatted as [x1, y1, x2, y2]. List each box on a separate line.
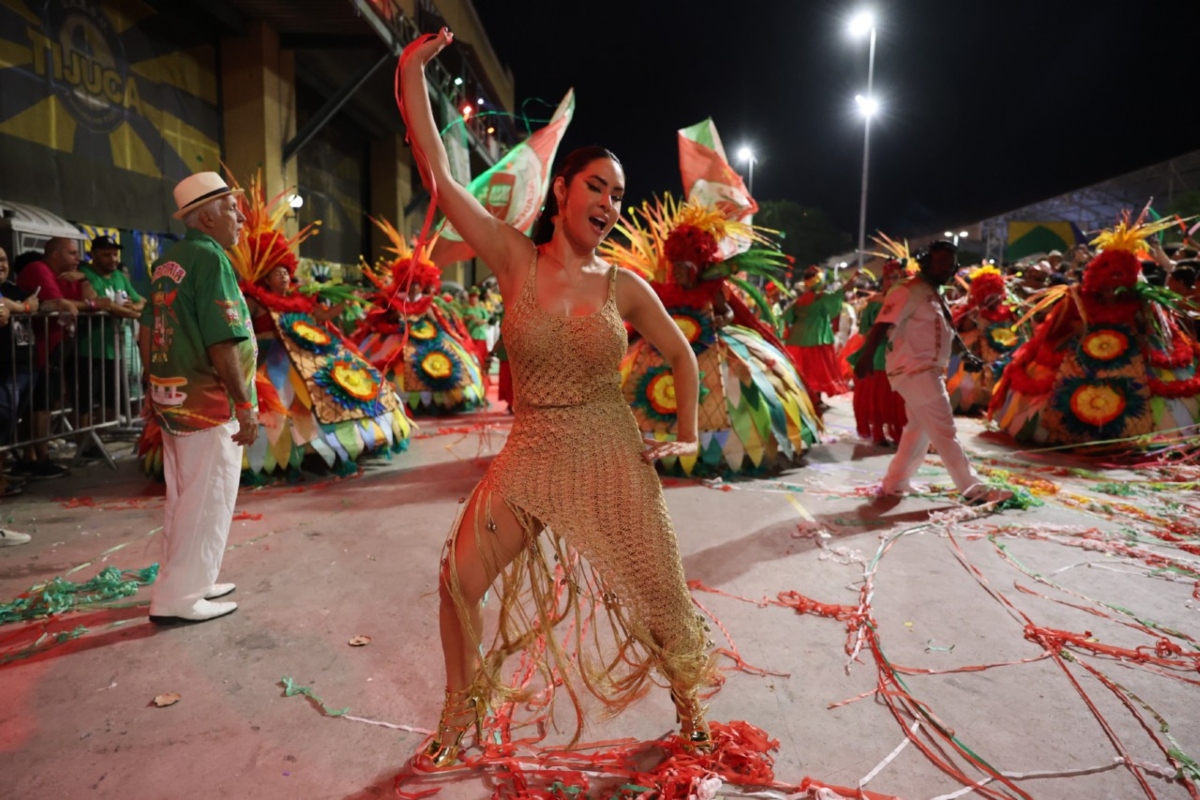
[400, 28, 533, 276]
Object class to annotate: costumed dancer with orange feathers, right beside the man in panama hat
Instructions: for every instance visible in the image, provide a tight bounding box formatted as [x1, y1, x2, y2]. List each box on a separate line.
[229, 176, 412, 479]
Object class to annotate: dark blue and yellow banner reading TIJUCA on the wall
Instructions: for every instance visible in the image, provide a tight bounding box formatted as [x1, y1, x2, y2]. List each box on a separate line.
[0, 0, 220, 230]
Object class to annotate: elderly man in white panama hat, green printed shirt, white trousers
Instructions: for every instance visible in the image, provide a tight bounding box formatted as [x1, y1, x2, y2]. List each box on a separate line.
[139, 173, 258, 625]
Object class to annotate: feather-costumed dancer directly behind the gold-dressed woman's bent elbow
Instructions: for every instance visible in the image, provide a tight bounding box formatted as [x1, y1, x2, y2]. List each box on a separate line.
[600, 194, 822, 475]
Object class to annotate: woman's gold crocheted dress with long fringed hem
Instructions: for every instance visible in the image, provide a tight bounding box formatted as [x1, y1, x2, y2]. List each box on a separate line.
[446, 259, 714, 742]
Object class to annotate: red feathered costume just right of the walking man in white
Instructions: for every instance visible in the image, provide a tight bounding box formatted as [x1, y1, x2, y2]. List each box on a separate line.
[946, 266, 1027, 414]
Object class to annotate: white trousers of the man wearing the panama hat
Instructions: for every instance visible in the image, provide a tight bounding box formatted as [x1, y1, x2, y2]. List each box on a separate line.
[150, 420, 241, 616]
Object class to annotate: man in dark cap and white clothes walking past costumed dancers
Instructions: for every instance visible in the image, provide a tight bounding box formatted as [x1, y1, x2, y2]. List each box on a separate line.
[854, 241, 1013, 505]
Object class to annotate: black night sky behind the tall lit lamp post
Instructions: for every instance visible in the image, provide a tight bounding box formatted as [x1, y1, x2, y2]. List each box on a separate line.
[475, 0, 1200, 235]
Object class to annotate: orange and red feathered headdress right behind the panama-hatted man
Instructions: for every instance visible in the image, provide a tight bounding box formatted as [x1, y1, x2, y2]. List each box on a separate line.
[226, 168, 320, 285]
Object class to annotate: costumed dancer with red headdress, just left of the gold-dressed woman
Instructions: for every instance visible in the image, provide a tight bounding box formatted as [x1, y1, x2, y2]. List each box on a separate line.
[354, 219, 487, 414]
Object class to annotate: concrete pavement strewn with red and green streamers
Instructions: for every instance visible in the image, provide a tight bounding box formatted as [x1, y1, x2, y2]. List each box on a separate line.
[0, 397, 1200, 799]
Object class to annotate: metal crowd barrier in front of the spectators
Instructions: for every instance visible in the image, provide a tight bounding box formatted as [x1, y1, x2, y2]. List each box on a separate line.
[0, 312, 144, 469]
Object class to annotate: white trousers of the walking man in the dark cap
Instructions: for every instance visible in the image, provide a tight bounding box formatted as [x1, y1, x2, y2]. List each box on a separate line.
[883, 369, 986, 497]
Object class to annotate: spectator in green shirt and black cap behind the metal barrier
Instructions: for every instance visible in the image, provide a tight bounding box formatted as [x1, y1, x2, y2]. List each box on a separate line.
[79, 236, 145, 443]
